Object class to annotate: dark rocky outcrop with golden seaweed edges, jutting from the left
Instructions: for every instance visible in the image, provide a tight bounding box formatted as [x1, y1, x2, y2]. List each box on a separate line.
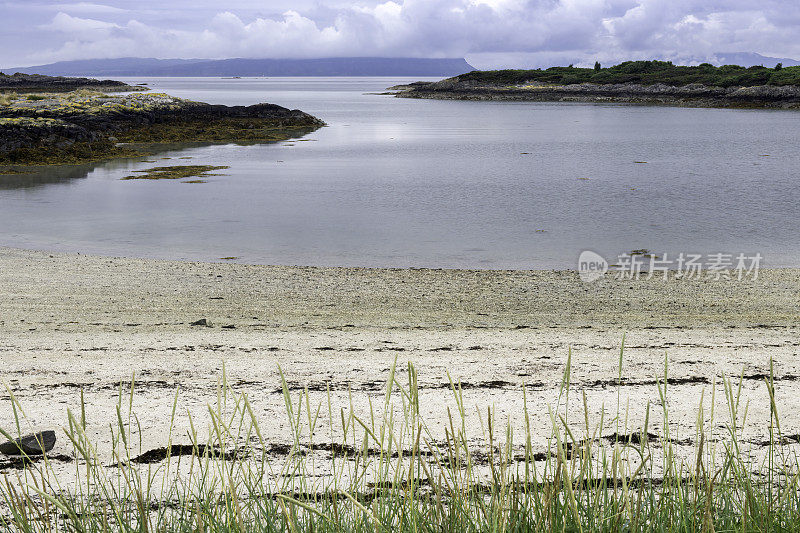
[0, 75, 324, 168]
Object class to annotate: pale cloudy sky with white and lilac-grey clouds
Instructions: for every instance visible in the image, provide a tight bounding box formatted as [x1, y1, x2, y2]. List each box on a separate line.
[0, 0, 800, 68]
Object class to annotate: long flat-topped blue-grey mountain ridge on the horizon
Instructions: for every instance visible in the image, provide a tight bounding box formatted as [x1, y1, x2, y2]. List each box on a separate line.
[0, 57, 475, 77]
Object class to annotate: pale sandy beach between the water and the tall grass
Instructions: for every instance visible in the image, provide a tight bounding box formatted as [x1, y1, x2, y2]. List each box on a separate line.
[0, 248, 800, 478]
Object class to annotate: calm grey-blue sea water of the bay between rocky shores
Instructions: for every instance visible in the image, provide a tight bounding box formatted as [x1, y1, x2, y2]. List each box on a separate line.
[0, 78, 800, 269]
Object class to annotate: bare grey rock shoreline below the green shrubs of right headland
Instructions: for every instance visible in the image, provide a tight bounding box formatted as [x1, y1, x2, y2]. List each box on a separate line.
[396, 78, 800, 109]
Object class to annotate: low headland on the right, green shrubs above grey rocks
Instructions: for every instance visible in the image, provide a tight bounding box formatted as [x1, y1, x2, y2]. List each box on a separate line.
[396, 61, 800, 109]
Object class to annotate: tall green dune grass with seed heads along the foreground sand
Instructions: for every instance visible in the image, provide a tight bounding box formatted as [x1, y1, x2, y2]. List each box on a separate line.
[0, 344, 800, 533]
